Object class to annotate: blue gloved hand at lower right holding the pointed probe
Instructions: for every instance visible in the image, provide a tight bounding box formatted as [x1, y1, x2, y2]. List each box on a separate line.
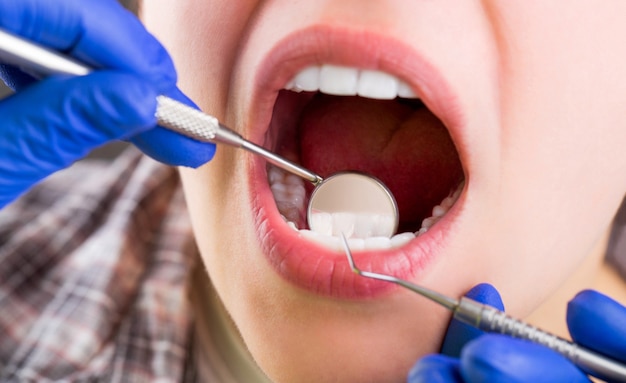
[408, 285, 626, 383]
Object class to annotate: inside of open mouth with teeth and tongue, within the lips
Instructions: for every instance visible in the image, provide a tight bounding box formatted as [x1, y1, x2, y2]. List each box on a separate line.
[268, 64, 464, 250]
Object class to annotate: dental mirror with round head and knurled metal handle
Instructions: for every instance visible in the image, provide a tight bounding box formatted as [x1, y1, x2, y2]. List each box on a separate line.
[0, 29, 399, 236]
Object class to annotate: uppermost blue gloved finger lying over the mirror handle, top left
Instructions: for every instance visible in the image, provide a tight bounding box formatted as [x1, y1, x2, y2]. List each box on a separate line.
[0, 0, 176, 93]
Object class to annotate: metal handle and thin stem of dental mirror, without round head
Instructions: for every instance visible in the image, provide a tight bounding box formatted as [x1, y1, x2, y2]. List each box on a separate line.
[0, 29, 322, 186]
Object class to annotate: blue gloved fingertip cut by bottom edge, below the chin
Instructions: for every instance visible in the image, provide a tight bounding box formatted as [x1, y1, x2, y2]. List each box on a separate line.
[407, 354, 464, 383]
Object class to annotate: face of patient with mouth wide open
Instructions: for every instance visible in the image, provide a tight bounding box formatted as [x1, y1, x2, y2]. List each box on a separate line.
[144, 0, 626, 382]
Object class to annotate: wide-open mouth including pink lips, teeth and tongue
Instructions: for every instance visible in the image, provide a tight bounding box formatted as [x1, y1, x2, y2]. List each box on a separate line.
[246, 31, 466, 297]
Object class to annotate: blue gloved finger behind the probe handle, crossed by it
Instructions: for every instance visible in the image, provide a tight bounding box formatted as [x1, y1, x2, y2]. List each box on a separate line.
[441, 283, 504, 357]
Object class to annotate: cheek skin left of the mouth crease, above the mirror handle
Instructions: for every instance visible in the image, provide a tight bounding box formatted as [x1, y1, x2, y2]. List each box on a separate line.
[141, 0, 258, 118]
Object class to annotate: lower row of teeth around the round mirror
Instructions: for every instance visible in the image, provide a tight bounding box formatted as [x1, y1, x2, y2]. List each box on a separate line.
[268, 166, 463, 251]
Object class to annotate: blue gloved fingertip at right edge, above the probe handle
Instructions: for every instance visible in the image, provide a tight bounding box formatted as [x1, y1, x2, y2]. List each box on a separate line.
[567, 290, 626, 362]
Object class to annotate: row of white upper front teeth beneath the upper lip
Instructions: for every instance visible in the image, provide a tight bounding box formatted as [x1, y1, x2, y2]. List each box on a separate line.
[285, 64, 418, 100]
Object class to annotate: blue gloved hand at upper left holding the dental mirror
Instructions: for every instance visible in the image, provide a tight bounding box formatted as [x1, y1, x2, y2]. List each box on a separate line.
[0, 0, 215, 207]
